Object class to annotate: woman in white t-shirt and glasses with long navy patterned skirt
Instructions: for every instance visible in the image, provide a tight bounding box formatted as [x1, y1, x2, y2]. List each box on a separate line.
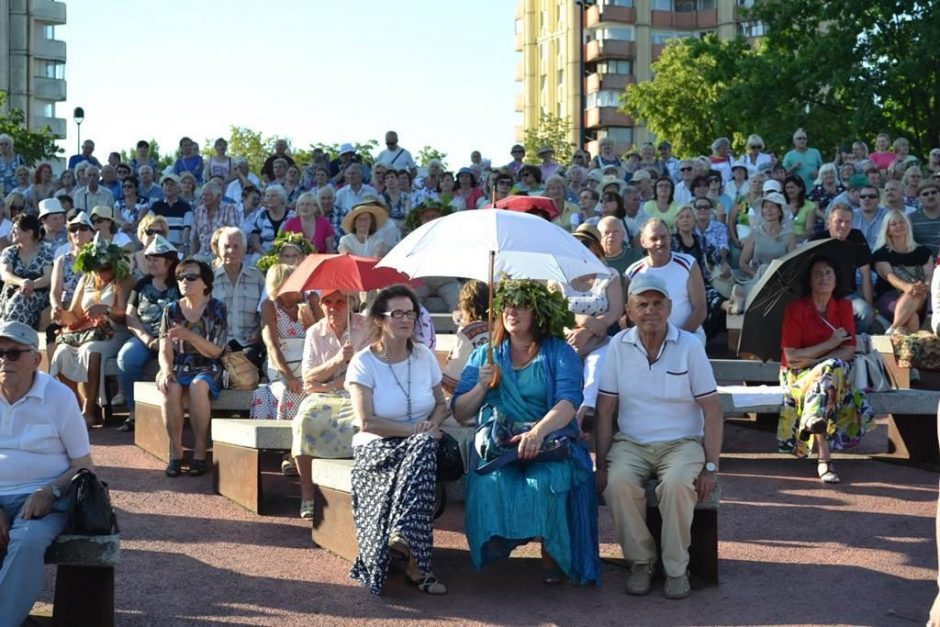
[346, 285, 447, 594]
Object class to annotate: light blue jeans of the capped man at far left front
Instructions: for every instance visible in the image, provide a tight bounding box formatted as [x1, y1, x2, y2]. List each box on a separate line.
[0, 494, 69, 627]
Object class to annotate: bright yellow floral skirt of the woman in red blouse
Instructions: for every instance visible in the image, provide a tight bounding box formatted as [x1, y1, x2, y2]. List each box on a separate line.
[777, 359, 874, 457]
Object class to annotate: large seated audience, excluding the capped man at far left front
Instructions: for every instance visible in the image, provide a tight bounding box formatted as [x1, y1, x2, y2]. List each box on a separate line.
[0, 129, 940, 620]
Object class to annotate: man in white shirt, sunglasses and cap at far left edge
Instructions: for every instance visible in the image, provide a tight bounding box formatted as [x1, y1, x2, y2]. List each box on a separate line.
[0, 322, 93, 627]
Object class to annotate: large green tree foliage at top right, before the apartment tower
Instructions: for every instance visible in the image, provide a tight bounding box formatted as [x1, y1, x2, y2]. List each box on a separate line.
[624, 0, 940, 156]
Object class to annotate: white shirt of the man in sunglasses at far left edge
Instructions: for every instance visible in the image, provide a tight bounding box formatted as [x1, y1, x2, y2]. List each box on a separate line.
[0, 372, 91, 496]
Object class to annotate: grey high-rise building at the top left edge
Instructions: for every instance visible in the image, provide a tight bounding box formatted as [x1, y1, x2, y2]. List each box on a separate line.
[0, 0, 66, 137]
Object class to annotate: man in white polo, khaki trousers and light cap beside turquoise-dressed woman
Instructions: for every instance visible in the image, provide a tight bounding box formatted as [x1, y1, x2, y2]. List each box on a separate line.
[595, 273, 723, 599]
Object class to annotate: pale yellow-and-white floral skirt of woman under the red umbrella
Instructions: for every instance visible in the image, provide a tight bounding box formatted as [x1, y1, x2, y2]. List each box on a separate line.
[291, 392, 359, 459]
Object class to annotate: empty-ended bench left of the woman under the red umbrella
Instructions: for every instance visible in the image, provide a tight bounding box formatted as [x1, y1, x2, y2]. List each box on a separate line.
[212, 418, 293, 514]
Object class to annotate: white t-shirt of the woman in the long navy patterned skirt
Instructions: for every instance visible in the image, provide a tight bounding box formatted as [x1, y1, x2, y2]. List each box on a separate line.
[346, 344, 441, 446]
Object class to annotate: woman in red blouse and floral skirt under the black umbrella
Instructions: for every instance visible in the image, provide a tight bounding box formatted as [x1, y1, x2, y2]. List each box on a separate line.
[777, 258, 874, 483]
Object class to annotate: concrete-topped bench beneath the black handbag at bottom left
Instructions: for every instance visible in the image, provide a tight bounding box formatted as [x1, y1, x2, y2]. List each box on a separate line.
[45, 534, 121, 627]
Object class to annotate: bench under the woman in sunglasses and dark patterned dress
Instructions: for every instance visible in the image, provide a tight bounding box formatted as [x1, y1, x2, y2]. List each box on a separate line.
[134, 381, 254, 462]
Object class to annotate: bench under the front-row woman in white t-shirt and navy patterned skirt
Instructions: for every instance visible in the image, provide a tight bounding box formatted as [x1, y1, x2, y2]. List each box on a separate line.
[311, 421, 475, 562]
